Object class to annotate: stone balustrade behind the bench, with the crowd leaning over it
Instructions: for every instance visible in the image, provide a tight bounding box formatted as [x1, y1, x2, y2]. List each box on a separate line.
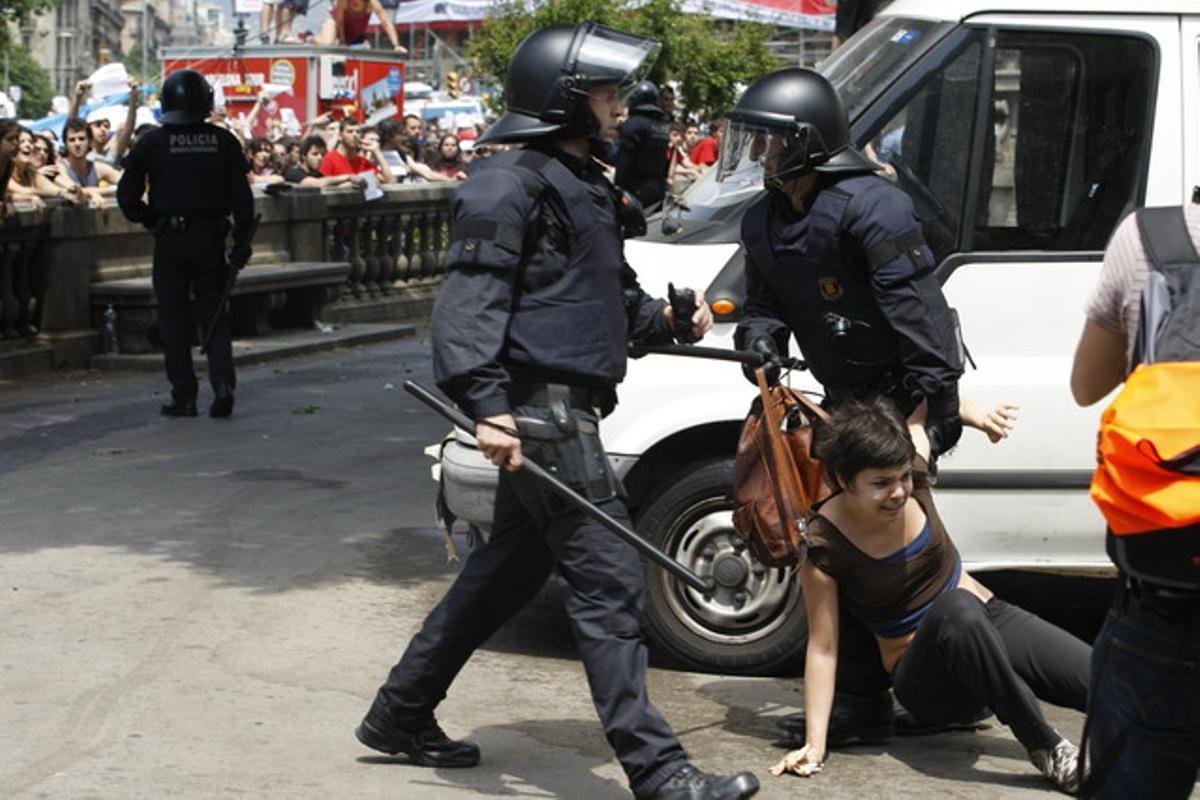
[0, 184, 454, 375]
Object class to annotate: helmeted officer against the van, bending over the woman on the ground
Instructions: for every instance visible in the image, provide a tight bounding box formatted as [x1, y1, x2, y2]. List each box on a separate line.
[718, 68, 962, 746]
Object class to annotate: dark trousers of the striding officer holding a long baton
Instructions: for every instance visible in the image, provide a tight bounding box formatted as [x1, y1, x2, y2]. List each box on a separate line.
[368, 408, 686, 793]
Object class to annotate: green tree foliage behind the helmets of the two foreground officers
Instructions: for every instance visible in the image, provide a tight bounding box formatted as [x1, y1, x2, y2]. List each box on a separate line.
[470, 0, 781, 116]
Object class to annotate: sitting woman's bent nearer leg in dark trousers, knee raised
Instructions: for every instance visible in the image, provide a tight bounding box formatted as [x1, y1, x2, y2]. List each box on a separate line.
[892, 589, 1061, 752]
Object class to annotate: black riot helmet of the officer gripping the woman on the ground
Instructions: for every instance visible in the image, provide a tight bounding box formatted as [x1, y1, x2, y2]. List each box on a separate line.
[716, 67, 878, 188]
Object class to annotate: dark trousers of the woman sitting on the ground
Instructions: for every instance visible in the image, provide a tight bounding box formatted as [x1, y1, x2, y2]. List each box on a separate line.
[893, 589, 1092, 751]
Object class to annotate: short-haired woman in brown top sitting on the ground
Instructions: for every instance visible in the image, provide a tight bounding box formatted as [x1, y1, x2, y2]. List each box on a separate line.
[772, 399, 1091, 793]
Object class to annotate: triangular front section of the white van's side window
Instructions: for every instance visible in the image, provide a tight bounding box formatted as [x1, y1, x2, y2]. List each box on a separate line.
[866, 37, 983, 259]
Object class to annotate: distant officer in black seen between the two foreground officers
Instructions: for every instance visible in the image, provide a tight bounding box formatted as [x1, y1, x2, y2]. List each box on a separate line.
[613, 80, 671, 209]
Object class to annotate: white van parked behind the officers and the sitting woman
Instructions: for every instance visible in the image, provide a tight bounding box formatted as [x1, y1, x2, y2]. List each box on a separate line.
[442, 0, 1200, 673]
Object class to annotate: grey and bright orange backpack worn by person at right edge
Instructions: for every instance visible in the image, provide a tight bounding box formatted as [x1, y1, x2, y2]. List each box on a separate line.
[1092, 206, 1200, 590]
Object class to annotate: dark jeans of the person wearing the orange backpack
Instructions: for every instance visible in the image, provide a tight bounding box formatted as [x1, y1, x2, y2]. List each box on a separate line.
[1085, 593, 1200, 800]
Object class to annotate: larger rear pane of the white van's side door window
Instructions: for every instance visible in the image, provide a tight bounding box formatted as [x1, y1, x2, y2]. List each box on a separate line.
[970, 31, 1154, 251]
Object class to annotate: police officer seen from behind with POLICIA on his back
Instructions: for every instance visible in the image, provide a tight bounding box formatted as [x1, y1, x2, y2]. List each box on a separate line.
[116, 70, 254, 417]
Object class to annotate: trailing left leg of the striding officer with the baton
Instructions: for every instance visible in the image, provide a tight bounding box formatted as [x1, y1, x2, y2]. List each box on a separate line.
[367, 471, 553, 730]
